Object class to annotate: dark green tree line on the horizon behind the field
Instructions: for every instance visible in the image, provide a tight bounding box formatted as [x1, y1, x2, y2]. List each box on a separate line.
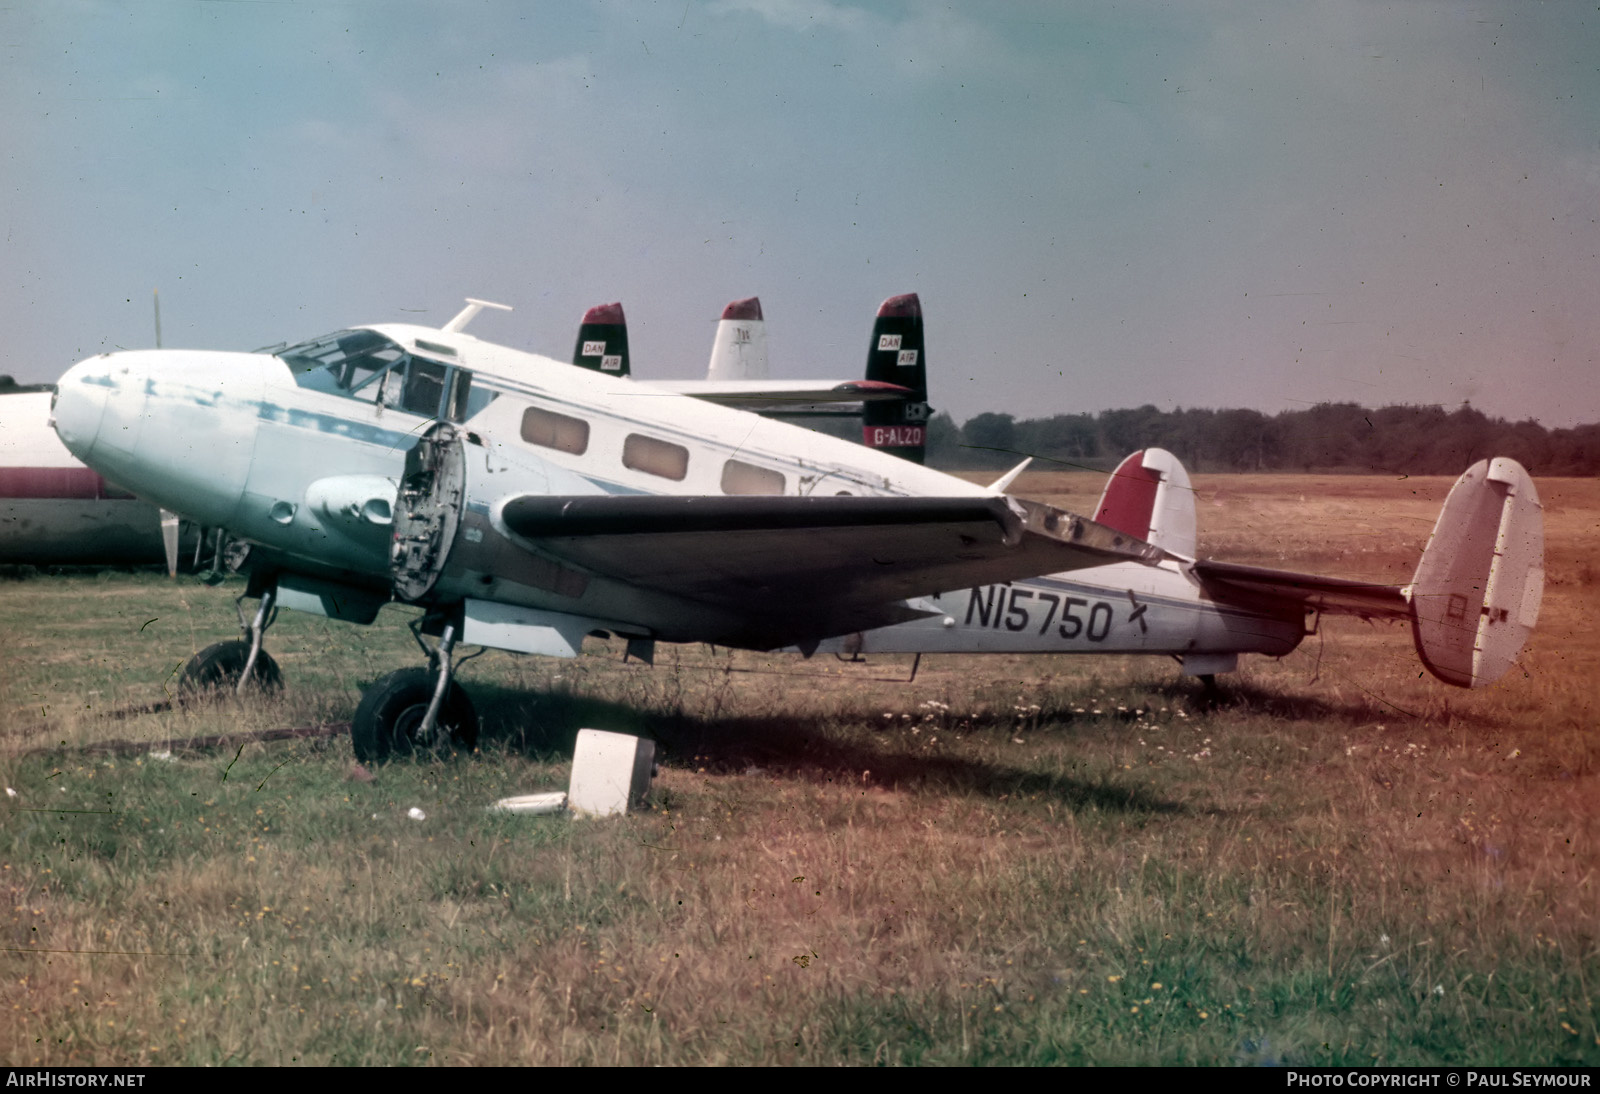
[928, 403, 1600, 475]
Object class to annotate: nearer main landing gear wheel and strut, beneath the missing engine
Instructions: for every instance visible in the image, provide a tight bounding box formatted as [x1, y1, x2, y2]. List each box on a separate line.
[360, 621, 482, 763]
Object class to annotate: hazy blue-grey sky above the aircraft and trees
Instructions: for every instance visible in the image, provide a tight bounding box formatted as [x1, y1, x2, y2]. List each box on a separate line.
[0, 0, 1600, 429]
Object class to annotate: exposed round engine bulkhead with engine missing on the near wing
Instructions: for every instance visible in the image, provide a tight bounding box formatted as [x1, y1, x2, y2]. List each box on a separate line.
[389, 422, 467, 601]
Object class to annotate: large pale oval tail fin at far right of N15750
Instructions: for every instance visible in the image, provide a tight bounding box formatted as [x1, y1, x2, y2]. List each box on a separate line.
[1406, 457, 1544, 688]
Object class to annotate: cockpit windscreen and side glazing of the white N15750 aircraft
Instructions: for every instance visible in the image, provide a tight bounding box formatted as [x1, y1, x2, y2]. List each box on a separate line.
[277, 331, 494, 422]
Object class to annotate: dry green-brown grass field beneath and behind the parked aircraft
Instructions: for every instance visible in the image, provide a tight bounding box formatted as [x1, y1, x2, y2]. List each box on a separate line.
[0, 473, 1600, 1065]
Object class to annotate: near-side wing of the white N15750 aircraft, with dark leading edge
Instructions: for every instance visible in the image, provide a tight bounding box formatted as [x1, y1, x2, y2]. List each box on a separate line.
[501, 494, 1166, 648]
